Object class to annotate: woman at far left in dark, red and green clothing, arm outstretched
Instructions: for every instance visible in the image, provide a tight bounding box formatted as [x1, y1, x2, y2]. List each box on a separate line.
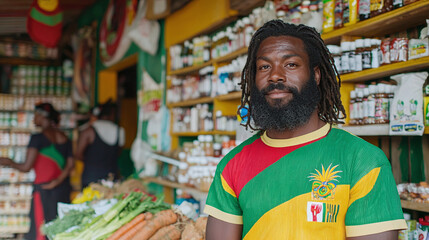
[0, 103, 74, 240]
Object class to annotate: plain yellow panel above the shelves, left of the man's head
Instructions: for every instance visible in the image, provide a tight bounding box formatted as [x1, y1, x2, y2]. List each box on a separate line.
[165, 0, 237, 47]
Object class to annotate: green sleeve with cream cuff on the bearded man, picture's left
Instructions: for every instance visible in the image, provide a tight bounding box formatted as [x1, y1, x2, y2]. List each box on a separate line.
[204, 166, 243, 224]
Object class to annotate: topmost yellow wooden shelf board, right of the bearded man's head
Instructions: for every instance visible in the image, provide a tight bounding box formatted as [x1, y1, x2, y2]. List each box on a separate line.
[322, 0, 429, 44]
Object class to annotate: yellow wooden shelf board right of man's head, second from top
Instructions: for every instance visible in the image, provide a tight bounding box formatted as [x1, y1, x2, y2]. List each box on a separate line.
[341, 57, 429, 82]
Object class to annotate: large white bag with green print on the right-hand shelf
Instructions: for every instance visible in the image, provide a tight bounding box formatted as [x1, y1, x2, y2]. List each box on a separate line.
[389, 72, 428, 136]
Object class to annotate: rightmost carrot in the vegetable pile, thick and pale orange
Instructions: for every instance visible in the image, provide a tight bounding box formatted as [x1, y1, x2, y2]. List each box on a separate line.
[132, 210, 177, 240]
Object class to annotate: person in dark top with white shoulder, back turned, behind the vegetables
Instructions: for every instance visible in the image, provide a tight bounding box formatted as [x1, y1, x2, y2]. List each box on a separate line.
[76, 100, 124, 188]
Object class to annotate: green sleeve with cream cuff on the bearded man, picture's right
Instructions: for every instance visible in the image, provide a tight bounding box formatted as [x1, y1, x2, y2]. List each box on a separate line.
[345, 161, 407, 237]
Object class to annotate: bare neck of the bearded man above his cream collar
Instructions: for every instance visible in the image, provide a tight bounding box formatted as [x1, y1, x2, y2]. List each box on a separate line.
[266, 111, 326, 139]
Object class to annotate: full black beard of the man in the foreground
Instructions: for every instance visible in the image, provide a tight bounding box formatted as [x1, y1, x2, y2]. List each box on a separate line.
[250, 74, 320, 131]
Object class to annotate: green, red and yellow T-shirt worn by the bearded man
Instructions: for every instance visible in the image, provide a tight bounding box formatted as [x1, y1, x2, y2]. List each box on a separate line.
[204, 124, 407, 240]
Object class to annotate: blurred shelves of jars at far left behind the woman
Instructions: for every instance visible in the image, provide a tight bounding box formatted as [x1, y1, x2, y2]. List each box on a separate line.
[0, 53, 75, 234]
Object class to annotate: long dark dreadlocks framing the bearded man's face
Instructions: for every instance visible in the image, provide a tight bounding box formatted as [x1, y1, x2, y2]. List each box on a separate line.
[237, 20, 346, 130]
